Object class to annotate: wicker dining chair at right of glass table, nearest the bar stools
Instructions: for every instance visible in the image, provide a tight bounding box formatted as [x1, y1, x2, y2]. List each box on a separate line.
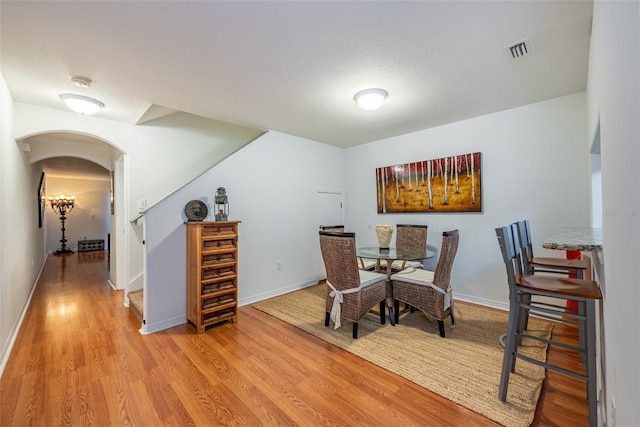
[391, 230, 459, 338]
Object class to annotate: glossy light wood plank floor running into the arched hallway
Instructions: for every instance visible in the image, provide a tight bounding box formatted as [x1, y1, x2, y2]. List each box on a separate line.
[0, 252, 588, 427]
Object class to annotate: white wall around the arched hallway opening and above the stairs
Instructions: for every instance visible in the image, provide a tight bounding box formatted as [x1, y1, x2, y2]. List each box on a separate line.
[12, 103, 261, 289]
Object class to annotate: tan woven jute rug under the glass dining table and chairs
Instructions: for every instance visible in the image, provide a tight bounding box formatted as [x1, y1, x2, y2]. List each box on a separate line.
[253, 284, 552, 426]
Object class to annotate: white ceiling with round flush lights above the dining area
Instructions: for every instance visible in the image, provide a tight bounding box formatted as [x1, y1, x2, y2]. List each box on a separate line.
[0, 0, 593, 147]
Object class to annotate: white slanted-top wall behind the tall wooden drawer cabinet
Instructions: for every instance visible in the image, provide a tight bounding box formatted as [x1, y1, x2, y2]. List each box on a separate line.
[144, 132, 345, 332]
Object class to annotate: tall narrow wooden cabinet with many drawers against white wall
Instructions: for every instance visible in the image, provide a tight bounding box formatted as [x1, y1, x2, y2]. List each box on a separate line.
[186, 221, 240, 333]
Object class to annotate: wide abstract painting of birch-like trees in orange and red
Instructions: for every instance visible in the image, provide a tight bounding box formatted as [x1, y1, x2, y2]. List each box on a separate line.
[376, 152, 482, 213]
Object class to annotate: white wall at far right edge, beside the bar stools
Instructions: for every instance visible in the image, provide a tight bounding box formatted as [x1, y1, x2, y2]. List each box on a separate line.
[588, 1, 640, 426]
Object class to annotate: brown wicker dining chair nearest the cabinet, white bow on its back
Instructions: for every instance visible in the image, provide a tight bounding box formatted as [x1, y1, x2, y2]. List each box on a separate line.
[319, 230, 387, 339]
